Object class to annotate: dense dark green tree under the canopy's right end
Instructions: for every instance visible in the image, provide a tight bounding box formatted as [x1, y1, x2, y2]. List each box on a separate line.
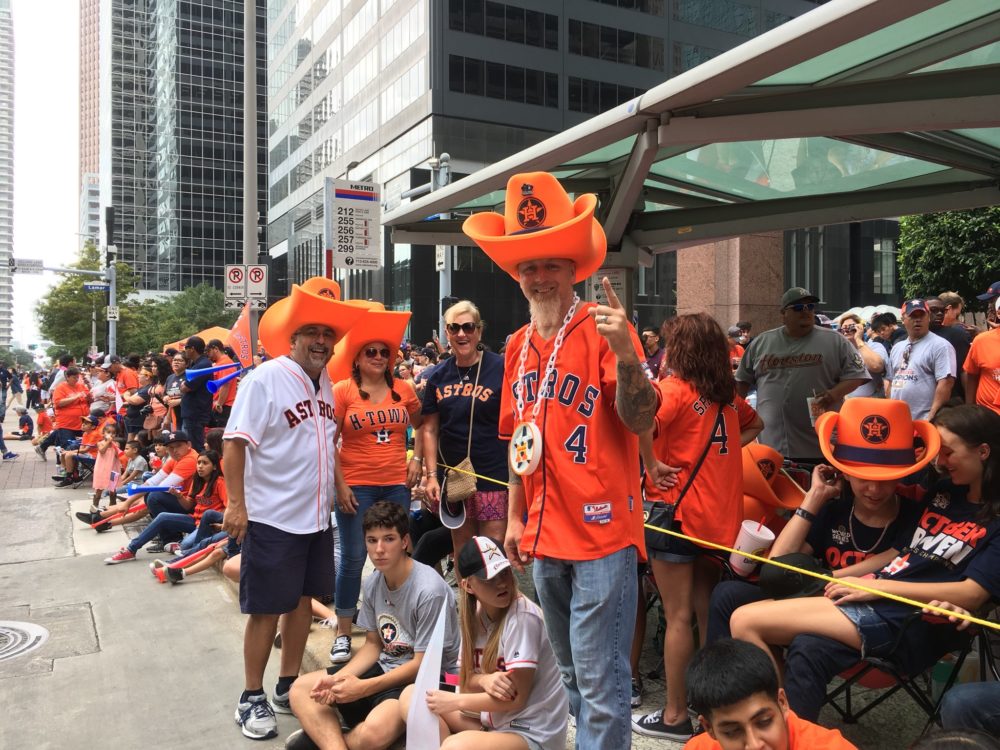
[898, 207, 1000, 300]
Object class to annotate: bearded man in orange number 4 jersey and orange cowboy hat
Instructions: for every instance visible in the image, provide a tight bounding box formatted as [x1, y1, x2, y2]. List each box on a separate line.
[463, 172, 645, 748]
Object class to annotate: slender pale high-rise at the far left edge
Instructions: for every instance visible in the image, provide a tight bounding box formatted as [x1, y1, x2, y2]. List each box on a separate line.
[0, 0, 14, 349]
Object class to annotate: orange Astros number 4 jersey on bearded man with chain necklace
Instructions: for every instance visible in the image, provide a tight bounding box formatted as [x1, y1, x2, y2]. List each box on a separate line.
[499, 303, 646, 560]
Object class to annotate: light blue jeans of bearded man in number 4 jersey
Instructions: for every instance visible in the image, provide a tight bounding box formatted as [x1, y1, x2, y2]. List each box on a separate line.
[532, 547, 638, 750]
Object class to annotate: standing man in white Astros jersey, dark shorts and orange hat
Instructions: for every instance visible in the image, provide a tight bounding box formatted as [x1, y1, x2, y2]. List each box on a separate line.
[222, 277, 366, 739]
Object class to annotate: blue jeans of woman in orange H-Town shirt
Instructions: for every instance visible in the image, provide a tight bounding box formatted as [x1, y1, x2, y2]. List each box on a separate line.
[333, 484, 410, 617]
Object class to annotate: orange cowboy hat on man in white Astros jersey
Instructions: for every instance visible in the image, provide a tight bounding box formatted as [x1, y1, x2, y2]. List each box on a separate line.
[257, 276, 365, 358]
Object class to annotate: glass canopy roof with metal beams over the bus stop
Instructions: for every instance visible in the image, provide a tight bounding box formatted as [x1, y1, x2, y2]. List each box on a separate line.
[385, 0, 1000, 252]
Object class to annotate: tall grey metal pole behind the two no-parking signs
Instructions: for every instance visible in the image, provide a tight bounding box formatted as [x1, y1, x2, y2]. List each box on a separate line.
[243, 0, 258, 355]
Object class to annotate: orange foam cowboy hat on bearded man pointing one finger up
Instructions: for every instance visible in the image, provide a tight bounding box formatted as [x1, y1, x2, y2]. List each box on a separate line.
[462, 172, 608, 282]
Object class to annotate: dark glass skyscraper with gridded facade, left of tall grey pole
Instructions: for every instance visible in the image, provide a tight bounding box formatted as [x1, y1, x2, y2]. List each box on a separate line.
[99, 0, 267, 293]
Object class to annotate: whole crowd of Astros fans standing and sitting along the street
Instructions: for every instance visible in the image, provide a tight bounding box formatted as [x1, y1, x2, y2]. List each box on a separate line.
[8, 173, 1000, 750]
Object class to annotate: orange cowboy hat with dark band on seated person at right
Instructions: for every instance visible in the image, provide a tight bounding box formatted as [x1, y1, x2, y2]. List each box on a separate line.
[816, 398, 941, 482]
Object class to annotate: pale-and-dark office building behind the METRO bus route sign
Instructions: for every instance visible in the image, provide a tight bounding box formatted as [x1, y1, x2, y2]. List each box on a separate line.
[267, 0, 821, 345]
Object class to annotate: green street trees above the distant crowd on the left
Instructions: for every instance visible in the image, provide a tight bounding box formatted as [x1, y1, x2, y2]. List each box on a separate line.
[36, 242, 237, 357]
